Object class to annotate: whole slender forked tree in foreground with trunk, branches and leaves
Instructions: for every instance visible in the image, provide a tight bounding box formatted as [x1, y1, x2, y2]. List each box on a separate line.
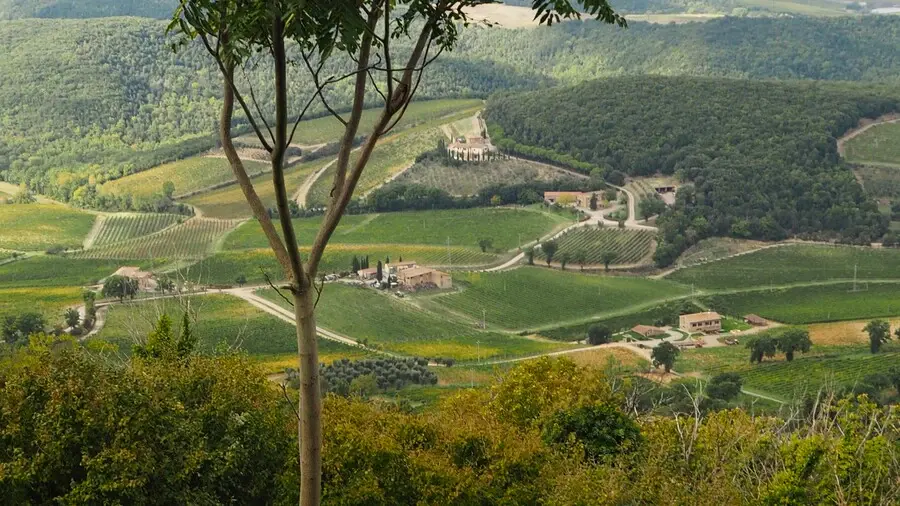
[169, 0, 625, 505]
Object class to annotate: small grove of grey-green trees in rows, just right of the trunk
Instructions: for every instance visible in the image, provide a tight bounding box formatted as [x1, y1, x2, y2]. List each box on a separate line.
[308, 357, 437, 397]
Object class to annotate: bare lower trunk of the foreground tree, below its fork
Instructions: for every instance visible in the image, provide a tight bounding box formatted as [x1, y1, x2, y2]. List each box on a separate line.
[294, 281, 322, 506]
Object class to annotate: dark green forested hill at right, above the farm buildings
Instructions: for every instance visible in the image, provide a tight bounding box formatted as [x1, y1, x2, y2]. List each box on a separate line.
[485, 77, 900, 265]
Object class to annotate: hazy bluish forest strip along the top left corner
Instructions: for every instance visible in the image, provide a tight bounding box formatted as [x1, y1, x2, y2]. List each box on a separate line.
[0, 0, 178, 20]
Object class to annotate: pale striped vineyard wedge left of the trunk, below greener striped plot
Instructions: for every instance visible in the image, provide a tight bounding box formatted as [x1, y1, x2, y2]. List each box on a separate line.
[75, 218, 239, 260]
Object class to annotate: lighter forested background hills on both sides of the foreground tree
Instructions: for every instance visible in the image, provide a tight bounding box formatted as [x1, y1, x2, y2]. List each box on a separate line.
[0, 17, 900, 209]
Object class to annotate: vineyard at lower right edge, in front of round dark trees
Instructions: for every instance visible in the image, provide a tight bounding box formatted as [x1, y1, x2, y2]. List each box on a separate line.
[675, 344, 900, 400]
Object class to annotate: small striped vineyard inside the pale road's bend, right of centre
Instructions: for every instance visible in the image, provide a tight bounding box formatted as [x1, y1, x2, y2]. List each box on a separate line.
[535, 226, 655, 265]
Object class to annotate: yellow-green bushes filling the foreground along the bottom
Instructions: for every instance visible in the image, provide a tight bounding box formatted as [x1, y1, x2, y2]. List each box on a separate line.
[0, 336, 900, 504]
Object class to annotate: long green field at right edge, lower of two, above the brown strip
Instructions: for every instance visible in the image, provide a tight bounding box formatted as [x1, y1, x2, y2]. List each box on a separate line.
[704, 282, 900, 324]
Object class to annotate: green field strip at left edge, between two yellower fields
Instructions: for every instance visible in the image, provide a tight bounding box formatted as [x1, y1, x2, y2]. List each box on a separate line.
[0, 255, 122, 288]
